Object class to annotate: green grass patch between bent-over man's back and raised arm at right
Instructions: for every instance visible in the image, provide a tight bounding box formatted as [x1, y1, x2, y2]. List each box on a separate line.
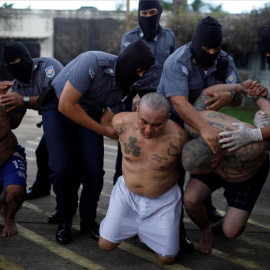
[219, 106, 258, 125]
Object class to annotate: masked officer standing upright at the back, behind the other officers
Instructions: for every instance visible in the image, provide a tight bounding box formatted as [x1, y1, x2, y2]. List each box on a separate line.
[121, 0, 175, 96]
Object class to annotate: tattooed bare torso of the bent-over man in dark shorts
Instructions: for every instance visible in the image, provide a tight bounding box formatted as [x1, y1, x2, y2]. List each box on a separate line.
[187, 110, 268, 183]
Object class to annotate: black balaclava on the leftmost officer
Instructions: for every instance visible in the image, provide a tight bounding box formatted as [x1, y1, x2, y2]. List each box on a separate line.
[3, 42, 33, 83]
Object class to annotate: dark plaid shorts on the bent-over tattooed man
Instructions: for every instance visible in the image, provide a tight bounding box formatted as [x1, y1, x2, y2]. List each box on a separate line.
[191, 156, 269, 212]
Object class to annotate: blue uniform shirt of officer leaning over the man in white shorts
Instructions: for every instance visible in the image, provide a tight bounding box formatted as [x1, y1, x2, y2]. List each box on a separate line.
[52, 51, 128, 113]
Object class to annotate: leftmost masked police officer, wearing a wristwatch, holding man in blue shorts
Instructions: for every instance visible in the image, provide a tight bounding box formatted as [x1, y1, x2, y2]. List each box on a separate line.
[0, 42, 63, 199]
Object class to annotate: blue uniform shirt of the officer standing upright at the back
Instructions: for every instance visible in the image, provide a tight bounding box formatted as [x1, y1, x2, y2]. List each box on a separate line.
[121, 27, 175, 90]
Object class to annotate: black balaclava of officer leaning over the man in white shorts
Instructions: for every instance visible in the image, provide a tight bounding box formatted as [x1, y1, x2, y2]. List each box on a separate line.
[115, 39, 155, 87]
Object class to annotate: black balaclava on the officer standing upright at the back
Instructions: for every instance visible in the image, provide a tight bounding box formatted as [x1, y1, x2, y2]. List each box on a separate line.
[138, 0, 162, 41]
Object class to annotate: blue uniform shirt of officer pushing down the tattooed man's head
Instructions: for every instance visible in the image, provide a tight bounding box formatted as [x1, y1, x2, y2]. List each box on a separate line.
[157, 42, 241, 115]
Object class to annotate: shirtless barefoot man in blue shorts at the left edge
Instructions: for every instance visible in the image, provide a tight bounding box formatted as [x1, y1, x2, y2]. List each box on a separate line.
[0, 87, 26, 237]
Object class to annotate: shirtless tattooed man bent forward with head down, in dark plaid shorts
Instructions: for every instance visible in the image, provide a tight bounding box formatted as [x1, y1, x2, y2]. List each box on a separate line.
[182, 88, 269, 253]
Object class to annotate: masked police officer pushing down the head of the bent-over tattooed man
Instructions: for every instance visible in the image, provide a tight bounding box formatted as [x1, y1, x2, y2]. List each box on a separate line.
[157, 16, 245, 228]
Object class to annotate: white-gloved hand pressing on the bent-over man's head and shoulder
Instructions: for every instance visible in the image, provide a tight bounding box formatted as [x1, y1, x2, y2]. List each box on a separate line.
[219, 123, 263, 152]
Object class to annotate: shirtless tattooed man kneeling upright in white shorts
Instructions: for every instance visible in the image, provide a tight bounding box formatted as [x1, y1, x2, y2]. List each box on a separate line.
[99, 92, 187, 264]
